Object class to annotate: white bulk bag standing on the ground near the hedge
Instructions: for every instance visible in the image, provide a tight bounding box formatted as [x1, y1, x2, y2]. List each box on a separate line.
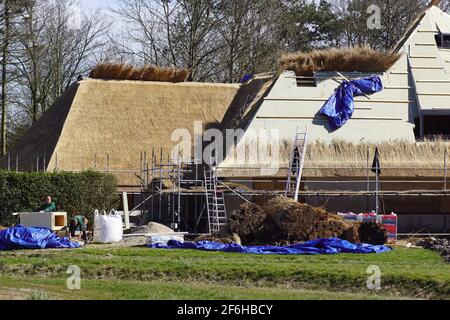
[94, 210, 123, 243]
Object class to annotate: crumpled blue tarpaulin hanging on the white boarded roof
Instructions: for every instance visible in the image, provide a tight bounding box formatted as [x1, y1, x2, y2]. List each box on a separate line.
[319, 77, 383, 130]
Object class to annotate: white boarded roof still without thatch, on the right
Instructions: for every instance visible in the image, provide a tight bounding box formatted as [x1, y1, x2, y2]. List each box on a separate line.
[221, 7, 450, 166]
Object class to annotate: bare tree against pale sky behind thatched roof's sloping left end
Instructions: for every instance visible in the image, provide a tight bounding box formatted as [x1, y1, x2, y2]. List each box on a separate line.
[11, 0, 109, 122]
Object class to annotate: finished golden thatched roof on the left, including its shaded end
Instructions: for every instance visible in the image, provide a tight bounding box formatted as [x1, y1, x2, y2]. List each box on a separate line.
[2, 79, 239, 185]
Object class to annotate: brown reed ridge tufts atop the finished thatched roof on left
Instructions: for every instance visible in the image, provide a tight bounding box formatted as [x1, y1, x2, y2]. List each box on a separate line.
[89, 63, 189, 83]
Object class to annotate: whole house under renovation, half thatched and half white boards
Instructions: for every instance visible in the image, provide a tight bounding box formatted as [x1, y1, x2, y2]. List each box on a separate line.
[1, 6, 450, 233]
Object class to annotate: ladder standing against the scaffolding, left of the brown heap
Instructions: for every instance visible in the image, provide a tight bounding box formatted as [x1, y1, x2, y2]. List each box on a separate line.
[204, 168, 227, 234]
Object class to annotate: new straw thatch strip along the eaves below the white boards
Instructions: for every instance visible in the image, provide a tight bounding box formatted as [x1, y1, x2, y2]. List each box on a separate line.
[219, 139, 450, 177]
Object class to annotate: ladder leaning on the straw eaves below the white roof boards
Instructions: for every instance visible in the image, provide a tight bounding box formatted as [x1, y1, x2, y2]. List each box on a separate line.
[285, 128, 308, 201]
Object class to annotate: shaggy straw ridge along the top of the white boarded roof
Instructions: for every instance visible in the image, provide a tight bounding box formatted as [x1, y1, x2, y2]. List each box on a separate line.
[279, 47, 401, 76]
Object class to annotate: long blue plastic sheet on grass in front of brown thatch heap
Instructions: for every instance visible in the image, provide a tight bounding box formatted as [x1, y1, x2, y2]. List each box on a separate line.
[149, 238, 392, 255]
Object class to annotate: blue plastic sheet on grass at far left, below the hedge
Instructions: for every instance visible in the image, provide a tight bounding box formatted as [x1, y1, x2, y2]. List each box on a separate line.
[0, 225, 80, 250]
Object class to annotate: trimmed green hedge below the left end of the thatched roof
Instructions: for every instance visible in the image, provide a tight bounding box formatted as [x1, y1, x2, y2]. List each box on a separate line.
[0, 171, 119, 226]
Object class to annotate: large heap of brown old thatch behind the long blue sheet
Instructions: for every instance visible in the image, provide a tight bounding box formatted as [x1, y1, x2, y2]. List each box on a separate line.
[214, 197, 388, 245]
